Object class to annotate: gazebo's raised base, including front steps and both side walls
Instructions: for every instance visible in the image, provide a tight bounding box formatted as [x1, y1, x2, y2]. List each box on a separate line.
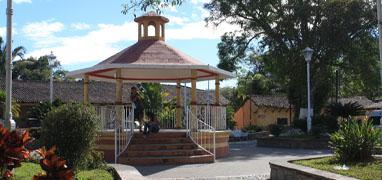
[97, 129, 229, 165]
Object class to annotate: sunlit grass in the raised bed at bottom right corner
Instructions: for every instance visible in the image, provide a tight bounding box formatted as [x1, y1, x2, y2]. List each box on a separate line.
[293, 157, 382, 180]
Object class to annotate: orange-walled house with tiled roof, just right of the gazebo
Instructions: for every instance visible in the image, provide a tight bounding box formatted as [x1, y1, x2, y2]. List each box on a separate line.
[234, 95, 294, 129]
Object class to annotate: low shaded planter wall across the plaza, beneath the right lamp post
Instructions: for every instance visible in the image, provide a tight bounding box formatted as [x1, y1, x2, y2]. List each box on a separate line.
[257, 138, 329, 149]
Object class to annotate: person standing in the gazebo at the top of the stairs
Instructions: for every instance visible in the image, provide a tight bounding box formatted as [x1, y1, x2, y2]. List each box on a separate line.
[130, 86, 144, 132]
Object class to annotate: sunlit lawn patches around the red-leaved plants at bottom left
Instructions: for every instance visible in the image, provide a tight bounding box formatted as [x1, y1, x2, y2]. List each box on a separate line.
[14, 163, 113, 180]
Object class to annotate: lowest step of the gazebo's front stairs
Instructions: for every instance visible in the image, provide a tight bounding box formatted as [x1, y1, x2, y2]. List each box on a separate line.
[118, 154, 214, 166]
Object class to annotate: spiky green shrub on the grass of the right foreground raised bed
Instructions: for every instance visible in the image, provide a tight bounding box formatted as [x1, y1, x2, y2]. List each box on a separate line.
[329, 120, 381, 162]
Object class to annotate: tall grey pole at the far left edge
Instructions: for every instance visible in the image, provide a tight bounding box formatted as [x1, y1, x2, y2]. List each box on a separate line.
[4, 0, 13, 129]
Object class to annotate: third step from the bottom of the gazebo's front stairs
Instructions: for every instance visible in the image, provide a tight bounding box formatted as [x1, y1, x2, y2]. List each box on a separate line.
[128, 143, 198, 151]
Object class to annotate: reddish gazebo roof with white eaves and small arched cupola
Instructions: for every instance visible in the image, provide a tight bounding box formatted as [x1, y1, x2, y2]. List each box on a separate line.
[68, 12, 234, 82]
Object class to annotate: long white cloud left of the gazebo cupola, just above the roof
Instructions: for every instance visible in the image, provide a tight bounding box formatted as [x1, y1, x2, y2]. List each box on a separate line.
[27, 22, 138, 65]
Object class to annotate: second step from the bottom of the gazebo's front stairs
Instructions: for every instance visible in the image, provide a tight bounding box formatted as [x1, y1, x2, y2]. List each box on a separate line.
[121, 149, 208, 157]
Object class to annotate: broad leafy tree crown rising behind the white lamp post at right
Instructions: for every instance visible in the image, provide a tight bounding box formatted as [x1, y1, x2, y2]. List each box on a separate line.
[205, 0, 377, 116]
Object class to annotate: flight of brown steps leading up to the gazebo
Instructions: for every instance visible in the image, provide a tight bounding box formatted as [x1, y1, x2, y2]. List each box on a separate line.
[118, 132, 214, 165]
